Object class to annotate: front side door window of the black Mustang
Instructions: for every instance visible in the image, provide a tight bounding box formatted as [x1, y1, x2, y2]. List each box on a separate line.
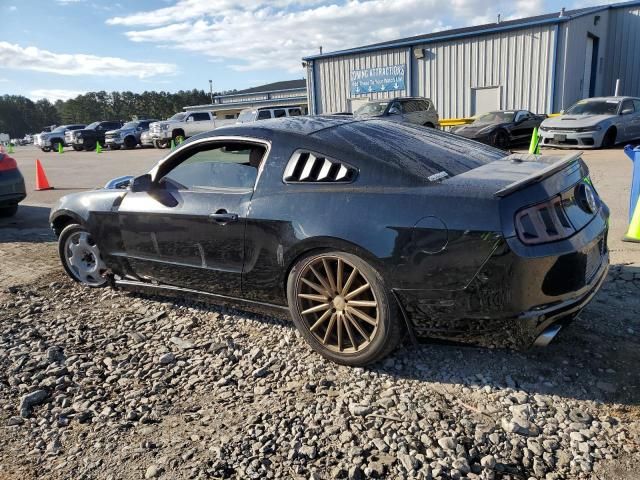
[160, 142, 266, 191]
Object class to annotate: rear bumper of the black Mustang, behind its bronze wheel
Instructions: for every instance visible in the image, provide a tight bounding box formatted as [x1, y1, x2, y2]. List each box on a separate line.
[395, 211, 609, 349]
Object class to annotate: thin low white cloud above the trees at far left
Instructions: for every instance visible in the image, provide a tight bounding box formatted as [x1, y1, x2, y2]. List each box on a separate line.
[0, 42, 177, 78]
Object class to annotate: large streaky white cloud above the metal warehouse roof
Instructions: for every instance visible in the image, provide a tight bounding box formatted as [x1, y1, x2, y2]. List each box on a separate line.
[107, 0, 556, 73]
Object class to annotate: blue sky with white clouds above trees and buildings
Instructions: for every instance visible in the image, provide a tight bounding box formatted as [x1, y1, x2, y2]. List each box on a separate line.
[0, 0, 607, 100]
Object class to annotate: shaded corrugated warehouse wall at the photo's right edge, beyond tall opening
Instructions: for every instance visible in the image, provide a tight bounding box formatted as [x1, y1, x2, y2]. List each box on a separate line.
[604, 6, 640, 97]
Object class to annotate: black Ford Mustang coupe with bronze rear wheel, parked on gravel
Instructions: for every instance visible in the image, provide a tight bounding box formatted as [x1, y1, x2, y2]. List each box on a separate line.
[51, 116, 609, 365]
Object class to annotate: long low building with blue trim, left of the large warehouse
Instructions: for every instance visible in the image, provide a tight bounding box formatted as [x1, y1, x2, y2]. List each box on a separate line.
[184, 79, 308, 119]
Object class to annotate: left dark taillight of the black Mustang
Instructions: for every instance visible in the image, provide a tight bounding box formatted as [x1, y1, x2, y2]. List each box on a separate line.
[516, 195, 575, 245]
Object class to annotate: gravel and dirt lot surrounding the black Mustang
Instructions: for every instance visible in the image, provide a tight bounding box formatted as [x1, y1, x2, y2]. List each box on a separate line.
[0, 143, 640, 480]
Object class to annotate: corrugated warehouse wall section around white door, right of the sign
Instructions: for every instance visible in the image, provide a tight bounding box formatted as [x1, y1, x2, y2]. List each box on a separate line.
[412, 26, 555, 118]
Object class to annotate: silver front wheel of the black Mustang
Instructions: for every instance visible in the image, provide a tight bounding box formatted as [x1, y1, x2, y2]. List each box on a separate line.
[58, 224, 107, 288]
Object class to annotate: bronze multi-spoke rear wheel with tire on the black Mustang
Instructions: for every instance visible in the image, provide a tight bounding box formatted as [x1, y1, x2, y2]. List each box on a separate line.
[287, 252, 402, 366]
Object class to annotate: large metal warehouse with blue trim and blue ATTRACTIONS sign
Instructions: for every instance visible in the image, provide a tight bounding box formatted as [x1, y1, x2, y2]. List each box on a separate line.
[304, 1, 640, 118]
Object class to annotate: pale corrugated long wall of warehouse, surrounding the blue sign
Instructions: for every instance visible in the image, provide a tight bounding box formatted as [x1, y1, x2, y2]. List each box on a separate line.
[307, 26, 556, 118]
